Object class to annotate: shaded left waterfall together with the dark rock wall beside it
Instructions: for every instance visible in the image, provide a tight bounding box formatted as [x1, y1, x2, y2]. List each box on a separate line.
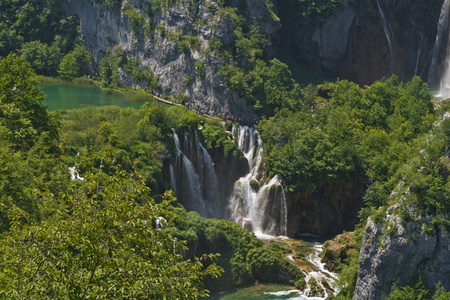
[164, 131, 248, 219]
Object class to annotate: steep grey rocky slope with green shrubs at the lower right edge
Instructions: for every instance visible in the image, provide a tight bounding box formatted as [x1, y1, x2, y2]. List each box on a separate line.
[353, 112, 450, 299]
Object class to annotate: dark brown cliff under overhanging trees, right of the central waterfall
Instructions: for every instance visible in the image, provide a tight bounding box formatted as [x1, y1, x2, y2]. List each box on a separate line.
[286, 175, 367, 236]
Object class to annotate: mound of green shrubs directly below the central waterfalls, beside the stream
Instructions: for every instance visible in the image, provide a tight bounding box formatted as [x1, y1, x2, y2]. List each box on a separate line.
[163, 203, 303, 290]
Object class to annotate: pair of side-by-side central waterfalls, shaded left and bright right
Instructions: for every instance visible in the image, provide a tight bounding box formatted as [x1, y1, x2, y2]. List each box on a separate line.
[170, 126, 287, 236]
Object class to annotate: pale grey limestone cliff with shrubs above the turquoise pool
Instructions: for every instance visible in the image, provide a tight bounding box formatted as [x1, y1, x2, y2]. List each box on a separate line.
[59, 0, 279, 119]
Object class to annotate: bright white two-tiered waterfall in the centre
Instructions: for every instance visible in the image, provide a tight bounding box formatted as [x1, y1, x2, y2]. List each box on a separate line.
[229, 126, 287, 235]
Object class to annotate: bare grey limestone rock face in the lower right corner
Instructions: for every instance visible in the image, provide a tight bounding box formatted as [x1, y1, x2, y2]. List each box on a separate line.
[353, 204, 450, 300]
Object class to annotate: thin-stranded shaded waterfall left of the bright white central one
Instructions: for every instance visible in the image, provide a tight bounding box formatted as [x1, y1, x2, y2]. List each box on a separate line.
[170, 130, 221, 218]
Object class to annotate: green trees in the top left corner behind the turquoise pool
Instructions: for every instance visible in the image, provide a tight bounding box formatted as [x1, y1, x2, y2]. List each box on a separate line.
[0, 0, 90, 79]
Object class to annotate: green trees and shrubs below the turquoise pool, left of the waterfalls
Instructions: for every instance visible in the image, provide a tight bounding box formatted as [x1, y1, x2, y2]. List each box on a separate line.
[0, 55, 303, 299]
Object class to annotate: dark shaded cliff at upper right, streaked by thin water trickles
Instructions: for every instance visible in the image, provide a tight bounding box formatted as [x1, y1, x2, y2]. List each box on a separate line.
[278, 0, 444, 84]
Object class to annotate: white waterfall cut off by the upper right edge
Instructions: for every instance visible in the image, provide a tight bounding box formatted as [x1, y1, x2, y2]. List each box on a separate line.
[428, 0, 450, 98]
